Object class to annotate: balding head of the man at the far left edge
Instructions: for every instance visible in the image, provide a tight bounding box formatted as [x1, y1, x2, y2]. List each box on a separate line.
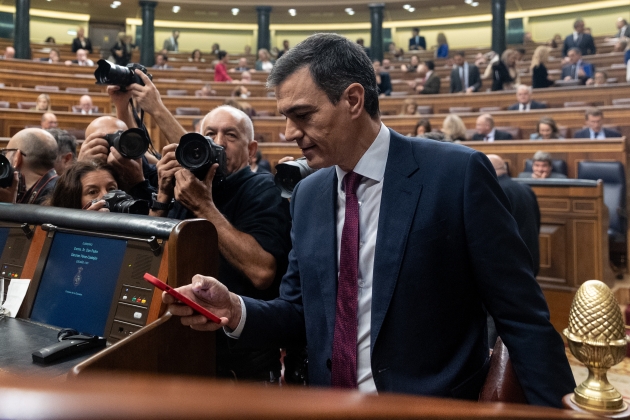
[7, 128, 57, 173]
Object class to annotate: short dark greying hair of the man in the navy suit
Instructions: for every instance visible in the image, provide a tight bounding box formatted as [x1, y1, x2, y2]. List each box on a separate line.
[267, 34, 379, 117]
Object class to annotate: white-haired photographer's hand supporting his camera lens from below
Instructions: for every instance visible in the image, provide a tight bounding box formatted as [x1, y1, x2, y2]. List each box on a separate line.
[175, 163, 219, 215]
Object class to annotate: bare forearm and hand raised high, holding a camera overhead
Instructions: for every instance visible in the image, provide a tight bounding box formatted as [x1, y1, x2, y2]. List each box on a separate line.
[127, 70, 187, 143]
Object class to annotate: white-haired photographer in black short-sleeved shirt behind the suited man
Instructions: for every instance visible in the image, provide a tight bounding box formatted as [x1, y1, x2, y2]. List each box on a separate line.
[130, 71, 291, 382]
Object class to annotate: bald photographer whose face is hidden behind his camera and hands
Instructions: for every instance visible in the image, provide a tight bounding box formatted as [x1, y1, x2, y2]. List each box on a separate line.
[77, 115, 155, 201]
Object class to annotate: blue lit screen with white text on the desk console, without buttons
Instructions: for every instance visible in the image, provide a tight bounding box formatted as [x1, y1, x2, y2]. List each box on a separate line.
[31, 232, 127, 336]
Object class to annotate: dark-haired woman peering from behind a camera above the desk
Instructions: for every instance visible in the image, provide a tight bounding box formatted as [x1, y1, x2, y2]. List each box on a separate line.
[47, 160, 118, 211]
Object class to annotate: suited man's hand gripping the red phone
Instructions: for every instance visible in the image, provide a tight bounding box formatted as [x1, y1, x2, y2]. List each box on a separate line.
[162, 274, 241, 331]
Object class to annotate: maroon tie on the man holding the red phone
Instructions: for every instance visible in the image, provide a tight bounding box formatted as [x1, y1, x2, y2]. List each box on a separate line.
[332, 172, 361, 388]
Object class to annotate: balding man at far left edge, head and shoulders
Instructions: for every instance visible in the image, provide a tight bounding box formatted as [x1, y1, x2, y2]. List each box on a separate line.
[0, 128, 58, 204]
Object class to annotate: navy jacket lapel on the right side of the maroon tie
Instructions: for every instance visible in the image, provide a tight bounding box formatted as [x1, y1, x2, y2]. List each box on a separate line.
[370, 130, 422, 351]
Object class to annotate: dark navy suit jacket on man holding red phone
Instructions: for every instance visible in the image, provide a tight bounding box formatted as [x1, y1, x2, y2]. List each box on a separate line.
[238, 131, 575, 407]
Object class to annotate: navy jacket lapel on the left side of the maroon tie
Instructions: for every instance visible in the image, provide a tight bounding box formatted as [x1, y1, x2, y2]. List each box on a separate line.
[311, 167, 338, 334]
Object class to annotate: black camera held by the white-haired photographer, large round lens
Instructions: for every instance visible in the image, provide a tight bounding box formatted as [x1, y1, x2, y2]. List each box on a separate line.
[175, 133, 227, 184]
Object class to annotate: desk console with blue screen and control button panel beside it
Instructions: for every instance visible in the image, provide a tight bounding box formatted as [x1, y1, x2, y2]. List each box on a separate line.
[29, 230, 164, 342]
